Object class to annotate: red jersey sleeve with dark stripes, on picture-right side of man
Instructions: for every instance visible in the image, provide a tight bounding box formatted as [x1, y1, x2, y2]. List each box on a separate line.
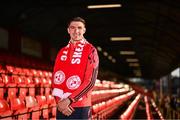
[69, 47, 99, 102]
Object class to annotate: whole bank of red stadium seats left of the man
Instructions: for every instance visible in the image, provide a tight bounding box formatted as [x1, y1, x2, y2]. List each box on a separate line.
[0, 59, 53, 119]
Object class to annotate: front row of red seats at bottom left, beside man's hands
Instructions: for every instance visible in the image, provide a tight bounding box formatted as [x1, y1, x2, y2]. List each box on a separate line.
[0, 95, 56, 119]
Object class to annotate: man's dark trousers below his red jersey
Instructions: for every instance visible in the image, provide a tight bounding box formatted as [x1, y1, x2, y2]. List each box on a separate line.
[56, 107, 91, 120]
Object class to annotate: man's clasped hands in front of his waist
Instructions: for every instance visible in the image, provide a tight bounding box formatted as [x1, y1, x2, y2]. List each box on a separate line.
[57, 98, 74, 116]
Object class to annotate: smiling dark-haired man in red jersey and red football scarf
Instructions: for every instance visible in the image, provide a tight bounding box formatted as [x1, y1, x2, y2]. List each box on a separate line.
[52, 17, 99, 119]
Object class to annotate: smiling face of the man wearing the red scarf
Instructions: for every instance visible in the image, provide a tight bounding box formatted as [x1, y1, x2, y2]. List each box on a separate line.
[68, 21, 86, 41]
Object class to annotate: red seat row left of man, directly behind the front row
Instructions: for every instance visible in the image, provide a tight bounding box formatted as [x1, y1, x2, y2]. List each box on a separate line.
[0, 74, 51, 101]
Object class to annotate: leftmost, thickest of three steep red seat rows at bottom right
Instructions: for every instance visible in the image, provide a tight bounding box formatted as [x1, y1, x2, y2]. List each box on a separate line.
[120, 94, 141, 120]
